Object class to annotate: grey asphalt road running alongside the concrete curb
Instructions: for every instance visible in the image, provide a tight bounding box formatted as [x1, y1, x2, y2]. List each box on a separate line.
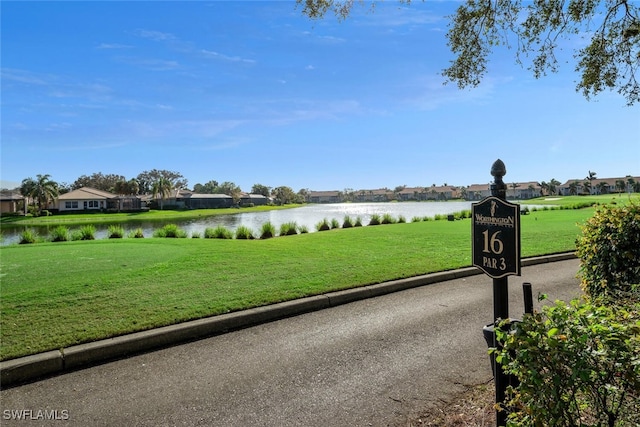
[0, 260, 580, 427]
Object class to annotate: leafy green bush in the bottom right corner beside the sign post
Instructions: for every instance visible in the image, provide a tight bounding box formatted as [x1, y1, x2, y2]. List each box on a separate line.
[497, 299, 640, 427]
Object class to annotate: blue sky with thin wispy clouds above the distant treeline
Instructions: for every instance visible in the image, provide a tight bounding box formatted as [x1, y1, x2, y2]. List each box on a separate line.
[0, 1, 640, 191]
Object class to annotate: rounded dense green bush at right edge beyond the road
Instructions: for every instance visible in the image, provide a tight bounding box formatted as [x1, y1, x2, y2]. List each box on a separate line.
[576, 202, 640, 298]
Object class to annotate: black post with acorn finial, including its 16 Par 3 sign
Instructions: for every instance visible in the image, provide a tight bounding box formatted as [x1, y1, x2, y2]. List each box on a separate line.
[471, 159, 520, 426]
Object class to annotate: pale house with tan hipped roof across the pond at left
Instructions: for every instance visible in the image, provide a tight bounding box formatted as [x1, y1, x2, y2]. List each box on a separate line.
[54, 187, 145, 212]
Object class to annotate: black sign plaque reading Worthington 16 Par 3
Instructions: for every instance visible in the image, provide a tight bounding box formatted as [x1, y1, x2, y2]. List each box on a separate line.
[471, 196, 520, 279]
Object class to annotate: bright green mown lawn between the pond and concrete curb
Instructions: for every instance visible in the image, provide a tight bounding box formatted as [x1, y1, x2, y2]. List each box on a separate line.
[0, 208, 593, 360]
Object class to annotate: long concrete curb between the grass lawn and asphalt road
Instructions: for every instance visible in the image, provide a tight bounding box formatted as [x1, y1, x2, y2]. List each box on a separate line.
[0, 253, 576, 388]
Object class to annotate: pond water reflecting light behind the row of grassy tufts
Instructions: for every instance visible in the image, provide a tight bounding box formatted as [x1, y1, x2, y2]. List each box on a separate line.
[1, 202, 532, 245]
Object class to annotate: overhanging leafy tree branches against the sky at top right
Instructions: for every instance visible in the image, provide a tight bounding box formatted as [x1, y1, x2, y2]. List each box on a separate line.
[296, 0, 640, 105]
